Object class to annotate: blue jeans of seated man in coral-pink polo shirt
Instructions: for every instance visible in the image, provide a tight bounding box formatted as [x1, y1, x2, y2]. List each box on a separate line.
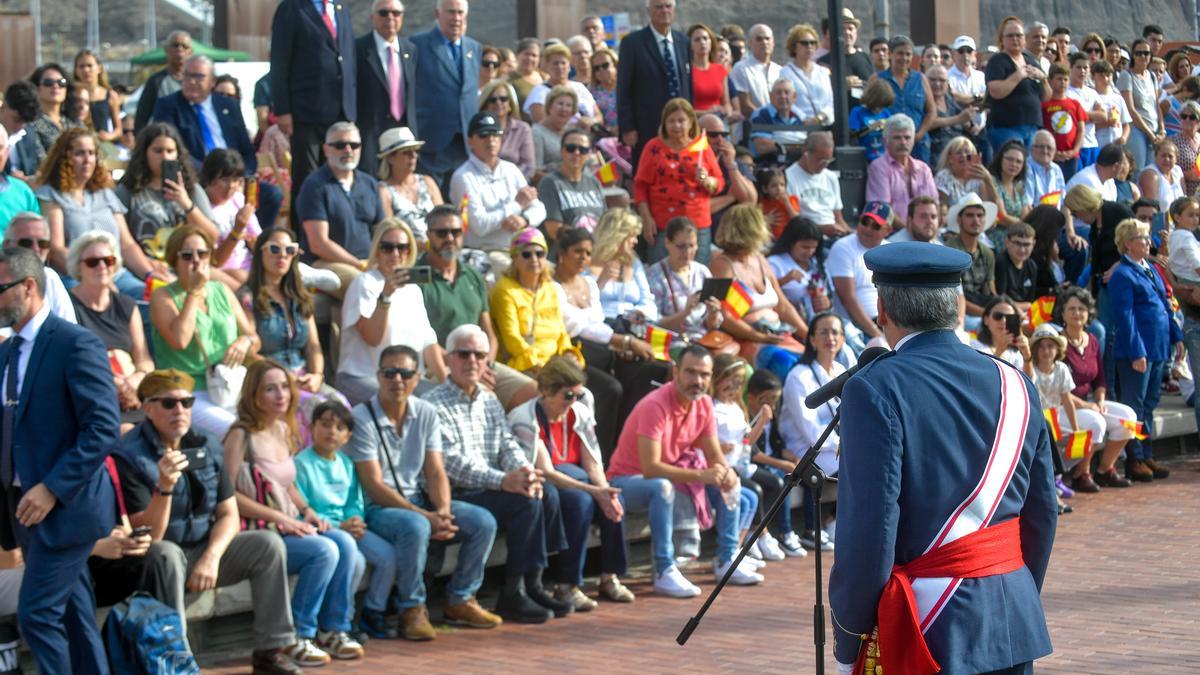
[611, 473, 739, 574]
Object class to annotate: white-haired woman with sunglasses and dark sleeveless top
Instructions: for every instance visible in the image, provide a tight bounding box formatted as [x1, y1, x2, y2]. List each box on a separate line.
[67, 229, 155, 422]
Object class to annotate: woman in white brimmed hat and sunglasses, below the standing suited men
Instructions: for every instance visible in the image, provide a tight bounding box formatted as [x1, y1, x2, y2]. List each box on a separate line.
[376, 126, 443, 243]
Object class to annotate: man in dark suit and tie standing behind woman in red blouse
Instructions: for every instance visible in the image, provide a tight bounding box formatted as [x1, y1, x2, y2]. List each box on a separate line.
[617, 0, 691, 167]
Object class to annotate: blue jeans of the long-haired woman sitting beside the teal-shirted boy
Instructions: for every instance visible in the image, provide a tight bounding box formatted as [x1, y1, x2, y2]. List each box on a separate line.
[283, 528, 366, 639]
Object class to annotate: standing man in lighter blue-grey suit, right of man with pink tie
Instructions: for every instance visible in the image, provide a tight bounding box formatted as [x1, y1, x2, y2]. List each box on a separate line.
[413, 0, 481, 195]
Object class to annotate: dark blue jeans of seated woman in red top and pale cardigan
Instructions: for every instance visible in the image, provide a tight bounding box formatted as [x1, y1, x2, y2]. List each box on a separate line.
[554, 464, 626, 586]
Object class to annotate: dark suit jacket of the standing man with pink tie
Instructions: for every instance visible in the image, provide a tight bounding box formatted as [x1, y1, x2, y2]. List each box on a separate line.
[354, 31, 420, 175]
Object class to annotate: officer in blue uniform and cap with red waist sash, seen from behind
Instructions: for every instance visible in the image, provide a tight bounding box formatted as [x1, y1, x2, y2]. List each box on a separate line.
[829, 243, 1057, 675]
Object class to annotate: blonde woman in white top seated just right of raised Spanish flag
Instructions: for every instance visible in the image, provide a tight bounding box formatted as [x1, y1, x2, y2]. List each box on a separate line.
[710, 204, 809, 358]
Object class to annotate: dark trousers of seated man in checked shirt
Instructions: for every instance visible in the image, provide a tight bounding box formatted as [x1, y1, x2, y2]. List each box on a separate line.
[455, 483, 566, 575]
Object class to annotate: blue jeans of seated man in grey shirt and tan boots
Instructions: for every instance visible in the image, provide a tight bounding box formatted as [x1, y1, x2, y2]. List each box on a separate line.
[367, 500, 496, 610]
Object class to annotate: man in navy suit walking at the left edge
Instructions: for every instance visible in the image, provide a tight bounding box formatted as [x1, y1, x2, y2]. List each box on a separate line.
[0, 249, 120, 674]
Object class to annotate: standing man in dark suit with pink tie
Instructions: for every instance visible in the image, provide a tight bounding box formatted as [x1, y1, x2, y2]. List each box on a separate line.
[354, 0, 420, 175]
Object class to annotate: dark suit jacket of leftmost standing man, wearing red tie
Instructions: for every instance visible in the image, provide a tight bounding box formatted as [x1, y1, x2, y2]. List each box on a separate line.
[271, 0, 358, 126]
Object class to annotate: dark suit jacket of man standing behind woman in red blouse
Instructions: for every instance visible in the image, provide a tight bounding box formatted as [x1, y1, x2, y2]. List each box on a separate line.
[617, 26, 691, 157]
